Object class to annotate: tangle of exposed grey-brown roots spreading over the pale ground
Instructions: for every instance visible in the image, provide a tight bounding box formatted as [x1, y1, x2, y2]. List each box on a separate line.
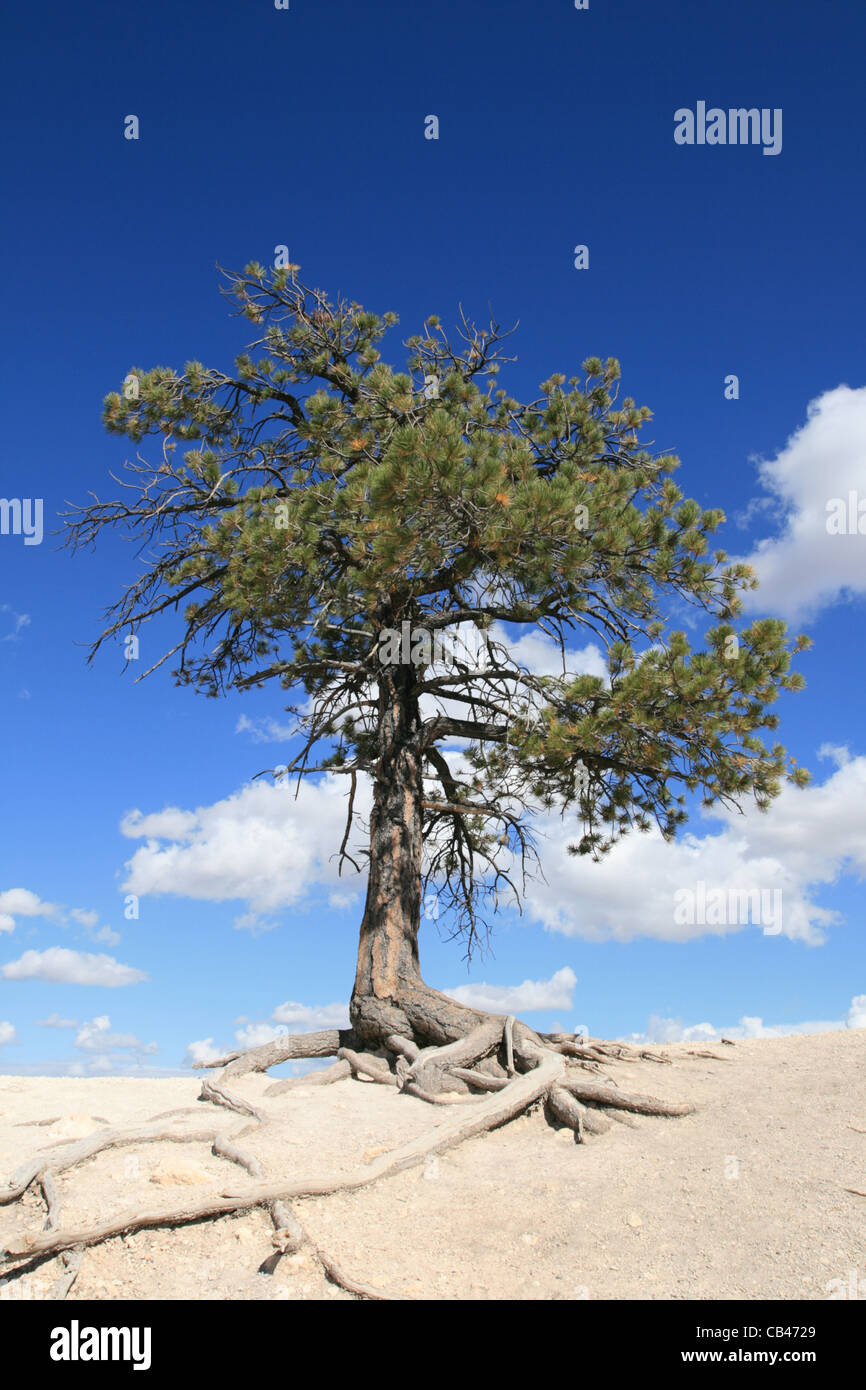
[0, 991, 692, 1300]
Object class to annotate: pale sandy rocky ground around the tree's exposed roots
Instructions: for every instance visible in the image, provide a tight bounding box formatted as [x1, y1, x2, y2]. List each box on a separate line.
[0, 1030, 866, 1302]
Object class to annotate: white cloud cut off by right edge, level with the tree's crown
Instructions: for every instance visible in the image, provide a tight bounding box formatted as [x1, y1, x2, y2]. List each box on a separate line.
[744, 385, 866, 619]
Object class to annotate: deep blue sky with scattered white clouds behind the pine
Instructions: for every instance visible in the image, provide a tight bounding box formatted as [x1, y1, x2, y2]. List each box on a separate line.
[0, 0, 866, 1072]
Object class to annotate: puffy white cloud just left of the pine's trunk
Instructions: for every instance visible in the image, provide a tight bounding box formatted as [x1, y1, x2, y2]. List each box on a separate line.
[121, 776, 370, 926]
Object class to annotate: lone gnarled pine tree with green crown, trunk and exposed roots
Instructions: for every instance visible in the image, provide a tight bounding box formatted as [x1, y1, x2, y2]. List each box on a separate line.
[20, 264, 808, 1273]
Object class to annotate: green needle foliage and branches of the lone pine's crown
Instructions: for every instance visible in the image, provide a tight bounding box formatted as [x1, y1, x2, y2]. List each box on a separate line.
[70, 264, 808, 942]
